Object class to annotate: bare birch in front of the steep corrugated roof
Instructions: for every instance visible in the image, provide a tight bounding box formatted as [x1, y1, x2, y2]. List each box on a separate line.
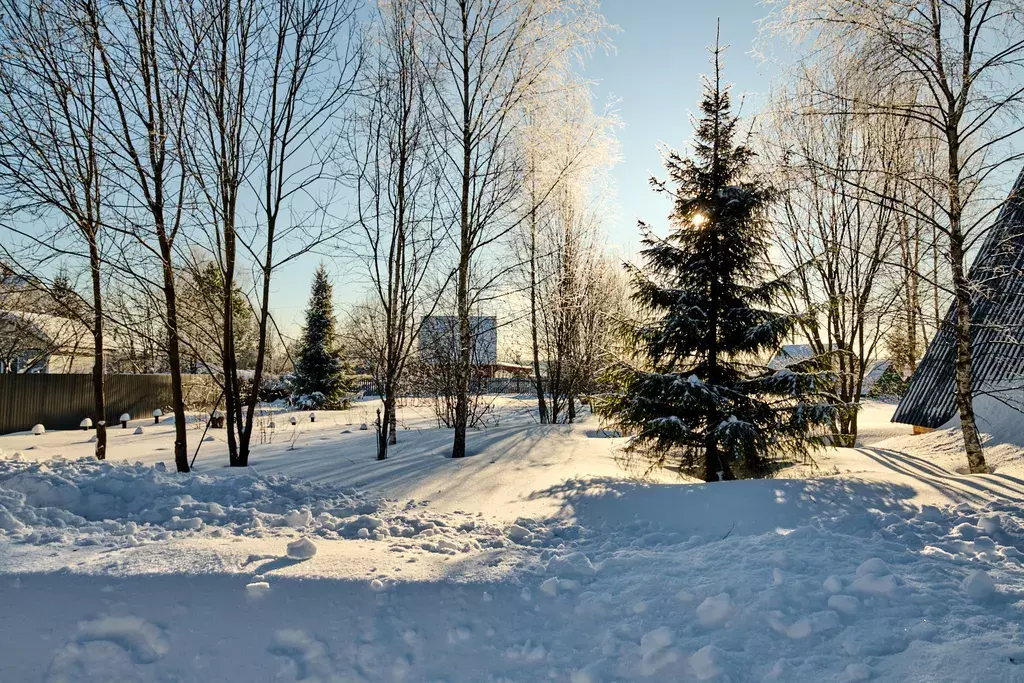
[768, 0, 1024, 473]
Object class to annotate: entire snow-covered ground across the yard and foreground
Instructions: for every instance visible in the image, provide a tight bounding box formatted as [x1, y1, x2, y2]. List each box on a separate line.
[0, 397, 1024, 683]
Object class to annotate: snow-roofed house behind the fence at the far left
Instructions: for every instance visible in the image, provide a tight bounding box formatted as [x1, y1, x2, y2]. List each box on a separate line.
[0, 311, 94, 374]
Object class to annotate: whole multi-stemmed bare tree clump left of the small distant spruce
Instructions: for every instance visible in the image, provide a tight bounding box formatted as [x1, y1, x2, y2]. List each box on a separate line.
[180, 0, 361, 467]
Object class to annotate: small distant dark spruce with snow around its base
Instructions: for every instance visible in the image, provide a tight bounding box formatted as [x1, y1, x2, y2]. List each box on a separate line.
[292, 263, 348, 409]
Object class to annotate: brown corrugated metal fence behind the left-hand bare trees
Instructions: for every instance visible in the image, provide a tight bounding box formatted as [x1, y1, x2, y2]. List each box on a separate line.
[0, 375, 219, 434]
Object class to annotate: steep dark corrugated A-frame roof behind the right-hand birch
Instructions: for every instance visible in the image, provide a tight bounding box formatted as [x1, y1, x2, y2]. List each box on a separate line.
[893, 165, 1024, 432]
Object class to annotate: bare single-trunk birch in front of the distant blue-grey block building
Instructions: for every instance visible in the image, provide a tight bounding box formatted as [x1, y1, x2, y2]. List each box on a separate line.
[418, 0, 604, 458]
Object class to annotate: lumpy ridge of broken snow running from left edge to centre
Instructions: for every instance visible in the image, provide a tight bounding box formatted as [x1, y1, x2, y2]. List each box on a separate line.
[0, 459, 578, 559]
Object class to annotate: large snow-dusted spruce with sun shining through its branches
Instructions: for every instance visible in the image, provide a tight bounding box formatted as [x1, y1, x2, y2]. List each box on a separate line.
[597, 30, 836, 481]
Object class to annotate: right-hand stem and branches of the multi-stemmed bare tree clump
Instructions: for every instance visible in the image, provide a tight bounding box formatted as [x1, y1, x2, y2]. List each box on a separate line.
[225, 0, 364, 467]
